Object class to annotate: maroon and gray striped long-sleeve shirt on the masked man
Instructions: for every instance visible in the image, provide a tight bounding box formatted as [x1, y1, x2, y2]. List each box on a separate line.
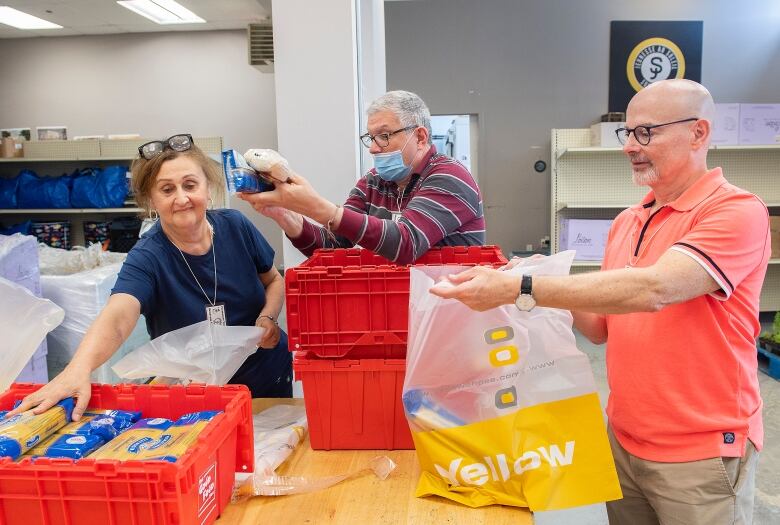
[291, 145, 485, 264]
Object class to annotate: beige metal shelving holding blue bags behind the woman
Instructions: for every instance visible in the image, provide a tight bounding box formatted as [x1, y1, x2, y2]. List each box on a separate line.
[0, 137, 222, 246]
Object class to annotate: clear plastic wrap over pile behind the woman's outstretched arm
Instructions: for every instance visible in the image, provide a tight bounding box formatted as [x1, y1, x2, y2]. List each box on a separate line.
[39, 262, 149, 383]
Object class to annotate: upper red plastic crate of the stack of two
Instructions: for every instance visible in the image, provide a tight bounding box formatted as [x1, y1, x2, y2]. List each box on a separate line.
[284, 246, 507, 359]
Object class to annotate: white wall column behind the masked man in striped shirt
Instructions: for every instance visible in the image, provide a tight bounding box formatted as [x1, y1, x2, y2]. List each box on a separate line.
[273, 0, 385, 267]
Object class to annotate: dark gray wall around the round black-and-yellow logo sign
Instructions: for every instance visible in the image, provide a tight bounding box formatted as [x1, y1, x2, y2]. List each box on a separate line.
[385, 0, 780, 251]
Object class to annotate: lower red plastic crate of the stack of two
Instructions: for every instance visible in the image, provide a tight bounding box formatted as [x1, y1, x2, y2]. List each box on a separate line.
[293, 352, 414, 450]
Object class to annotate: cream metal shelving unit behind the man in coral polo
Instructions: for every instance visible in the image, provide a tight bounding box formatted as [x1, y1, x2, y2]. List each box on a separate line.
[550, 129, 780, 311]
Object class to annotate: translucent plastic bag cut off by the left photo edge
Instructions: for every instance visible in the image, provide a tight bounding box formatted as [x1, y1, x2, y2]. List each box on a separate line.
[0, 277, 65, 392]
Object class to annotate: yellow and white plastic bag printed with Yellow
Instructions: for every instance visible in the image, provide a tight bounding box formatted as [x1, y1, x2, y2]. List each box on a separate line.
[403, 252, 622, 511]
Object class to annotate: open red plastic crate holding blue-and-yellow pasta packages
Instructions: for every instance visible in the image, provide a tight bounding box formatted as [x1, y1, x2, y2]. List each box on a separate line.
[0, 384, 254, 525]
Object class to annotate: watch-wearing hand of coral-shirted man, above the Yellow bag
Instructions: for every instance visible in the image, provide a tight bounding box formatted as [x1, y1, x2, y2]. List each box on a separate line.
[430, 266, 520, 312]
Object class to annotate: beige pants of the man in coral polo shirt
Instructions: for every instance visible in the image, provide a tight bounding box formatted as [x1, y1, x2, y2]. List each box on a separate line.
[607, 428, 758, 525]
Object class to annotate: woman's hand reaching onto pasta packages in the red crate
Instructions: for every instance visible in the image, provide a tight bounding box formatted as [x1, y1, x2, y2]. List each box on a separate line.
[8, 366, 92, 421]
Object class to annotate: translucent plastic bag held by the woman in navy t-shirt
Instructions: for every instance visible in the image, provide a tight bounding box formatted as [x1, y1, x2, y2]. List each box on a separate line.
[112, 321, 265, 385]
